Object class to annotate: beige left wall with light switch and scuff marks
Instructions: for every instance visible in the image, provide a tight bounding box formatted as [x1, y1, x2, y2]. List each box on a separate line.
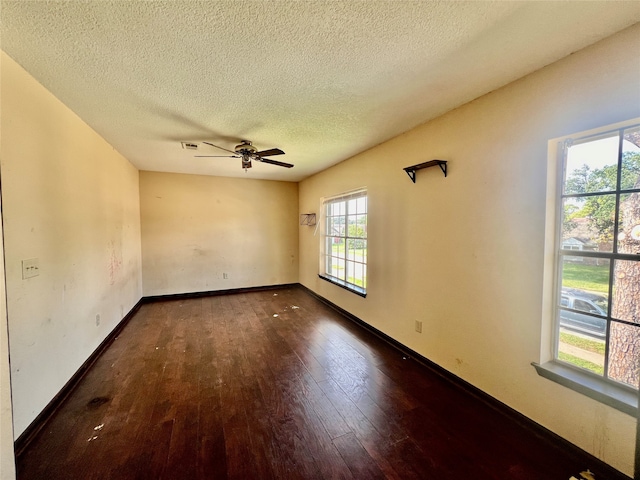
[0, 53, 142, 436]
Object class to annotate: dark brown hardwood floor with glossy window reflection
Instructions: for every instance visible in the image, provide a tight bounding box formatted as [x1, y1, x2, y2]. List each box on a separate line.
[17, 287, 626, 480]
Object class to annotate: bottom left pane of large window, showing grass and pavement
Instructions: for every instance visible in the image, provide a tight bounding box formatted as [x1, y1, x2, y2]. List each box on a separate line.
[558, 326, 605, 375]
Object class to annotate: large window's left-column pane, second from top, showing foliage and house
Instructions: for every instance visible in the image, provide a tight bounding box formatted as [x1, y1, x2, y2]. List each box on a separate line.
[562, 195, 616, 252]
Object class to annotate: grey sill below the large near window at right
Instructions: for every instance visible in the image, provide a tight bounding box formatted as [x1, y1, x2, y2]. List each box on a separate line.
[532, 362, 638, 417]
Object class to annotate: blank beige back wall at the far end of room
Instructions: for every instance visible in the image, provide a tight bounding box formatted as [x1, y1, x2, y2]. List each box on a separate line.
[140, 172, 298, 296]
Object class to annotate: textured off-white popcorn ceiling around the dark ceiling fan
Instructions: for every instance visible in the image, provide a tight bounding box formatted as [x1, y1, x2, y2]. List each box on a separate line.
[0, 0, 640, 181]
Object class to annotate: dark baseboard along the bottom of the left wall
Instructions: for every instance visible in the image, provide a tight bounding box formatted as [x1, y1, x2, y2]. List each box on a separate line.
[13, 299, 144, 458]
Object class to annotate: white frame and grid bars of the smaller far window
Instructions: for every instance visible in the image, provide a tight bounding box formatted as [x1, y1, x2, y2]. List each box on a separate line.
[318, 188, 369, 297]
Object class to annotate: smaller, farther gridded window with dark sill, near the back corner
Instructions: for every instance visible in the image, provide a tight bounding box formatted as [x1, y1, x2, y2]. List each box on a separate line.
[320, 189, 367, 296]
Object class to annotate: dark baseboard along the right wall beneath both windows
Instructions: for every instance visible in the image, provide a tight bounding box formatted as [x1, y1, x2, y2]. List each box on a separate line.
[299, 284, 631, 480]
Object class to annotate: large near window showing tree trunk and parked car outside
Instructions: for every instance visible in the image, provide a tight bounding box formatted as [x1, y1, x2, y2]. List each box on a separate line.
[555, 125, 640, 389]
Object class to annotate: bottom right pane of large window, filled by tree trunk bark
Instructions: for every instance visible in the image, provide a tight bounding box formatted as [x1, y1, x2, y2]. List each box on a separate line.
[608, 322, 640, 388]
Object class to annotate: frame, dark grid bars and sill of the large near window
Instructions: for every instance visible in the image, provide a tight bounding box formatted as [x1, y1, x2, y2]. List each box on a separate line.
[532, 118, 640, 415]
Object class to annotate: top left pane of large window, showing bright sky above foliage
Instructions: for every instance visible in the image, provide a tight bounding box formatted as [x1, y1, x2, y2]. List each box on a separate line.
[564, 134, 619, 194]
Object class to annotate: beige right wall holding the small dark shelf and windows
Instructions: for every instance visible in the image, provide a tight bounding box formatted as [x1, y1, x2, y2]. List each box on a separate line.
[300, 26, 640, 475]
